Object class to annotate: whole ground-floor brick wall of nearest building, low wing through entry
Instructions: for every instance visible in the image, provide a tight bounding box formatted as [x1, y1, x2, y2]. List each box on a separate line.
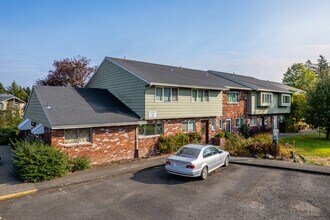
[47, 117, 224, 164]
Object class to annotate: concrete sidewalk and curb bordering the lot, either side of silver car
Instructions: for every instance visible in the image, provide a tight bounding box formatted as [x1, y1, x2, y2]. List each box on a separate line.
[0, 155, 330, 201]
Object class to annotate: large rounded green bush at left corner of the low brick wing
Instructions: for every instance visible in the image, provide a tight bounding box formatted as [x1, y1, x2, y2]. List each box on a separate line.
[13, 141, 69, 182]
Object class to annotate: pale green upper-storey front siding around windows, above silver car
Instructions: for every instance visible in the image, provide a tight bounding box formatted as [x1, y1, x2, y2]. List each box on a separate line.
[145, 87, 222, 119]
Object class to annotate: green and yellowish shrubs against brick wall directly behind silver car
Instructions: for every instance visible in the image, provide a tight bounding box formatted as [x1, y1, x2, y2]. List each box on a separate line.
[159, 132, 203, 153]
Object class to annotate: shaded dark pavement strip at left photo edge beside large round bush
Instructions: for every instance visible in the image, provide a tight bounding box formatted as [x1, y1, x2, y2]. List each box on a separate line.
[0, 145, 21, 186]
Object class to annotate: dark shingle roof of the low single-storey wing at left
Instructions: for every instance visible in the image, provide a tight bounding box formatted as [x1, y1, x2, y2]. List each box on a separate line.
[33, 86, 140, 128]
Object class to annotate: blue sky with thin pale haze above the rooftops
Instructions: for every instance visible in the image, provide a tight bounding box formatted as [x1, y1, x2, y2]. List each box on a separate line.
[0, 0, 330, 86]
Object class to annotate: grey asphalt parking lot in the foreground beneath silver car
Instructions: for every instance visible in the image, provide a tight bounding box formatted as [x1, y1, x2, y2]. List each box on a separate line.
[0, 164, 330, 219]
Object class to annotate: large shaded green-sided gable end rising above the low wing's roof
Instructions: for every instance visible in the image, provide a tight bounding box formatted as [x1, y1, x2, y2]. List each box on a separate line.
[87, 60, 147, 118]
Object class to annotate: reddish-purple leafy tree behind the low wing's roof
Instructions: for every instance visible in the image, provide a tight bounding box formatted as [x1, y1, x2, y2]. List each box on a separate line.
[36, 56, 96, 87]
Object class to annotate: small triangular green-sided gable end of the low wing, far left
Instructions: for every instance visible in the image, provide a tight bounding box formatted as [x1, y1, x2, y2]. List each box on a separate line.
[24, 91, 51, 128]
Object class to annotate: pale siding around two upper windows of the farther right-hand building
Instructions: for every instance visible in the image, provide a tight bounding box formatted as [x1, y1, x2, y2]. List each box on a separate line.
[247, 91, 291, 115]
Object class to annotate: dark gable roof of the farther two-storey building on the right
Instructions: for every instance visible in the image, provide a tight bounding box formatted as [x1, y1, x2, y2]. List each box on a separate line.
[208, 70, 299, 93]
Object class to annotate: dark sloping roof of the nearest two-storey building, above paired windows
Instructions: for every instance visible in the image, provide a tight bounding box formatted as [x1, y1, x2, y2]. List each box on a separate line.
[106, 57, 250, 90]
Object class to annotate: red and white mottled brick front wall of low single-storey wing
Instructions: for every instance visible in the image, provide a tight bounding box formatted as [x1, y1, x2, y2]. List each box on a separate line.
[51, 126, 136, 164]
